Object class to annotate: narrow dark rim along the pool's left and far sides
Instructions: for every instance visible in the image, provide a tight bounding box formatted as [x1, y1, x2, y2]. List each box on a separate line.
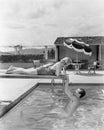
[0, 82, 104, 119]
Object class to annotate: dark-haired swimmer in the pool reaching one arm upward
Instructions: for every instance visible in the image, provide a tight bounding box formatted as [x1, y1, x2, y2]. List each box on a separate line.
[52, 76, 86, 117]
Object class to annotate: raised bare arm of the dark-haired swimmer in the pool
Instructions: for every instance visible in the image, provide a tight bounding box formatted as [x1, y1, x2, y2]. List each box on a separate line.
[65, 77, 77, 100]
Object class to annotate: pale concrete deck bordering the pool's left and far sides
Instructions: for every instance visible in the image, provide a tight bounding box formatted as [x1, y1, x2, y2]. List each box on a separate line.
[0, 71, 104, 101]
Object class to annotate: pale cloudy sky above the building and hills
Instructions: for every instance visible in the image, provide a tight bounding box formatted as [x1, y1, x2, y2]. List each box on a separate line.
[0, 0, 104, 46]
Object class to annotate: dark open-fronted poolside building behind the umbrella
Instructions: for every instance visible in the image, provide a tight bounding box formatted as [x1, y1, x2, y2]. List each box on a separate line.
[54, 36, 104, 62]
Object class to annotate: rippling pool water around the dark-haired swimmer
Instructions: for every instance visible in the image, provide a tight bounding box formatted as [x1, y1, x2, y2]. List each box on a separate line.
[0, 84, 104, 130]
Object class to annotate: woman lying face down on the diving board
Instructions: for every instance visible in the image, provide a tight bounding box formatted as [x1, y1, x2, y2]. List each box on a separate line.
[6, 57, 71, 76]
